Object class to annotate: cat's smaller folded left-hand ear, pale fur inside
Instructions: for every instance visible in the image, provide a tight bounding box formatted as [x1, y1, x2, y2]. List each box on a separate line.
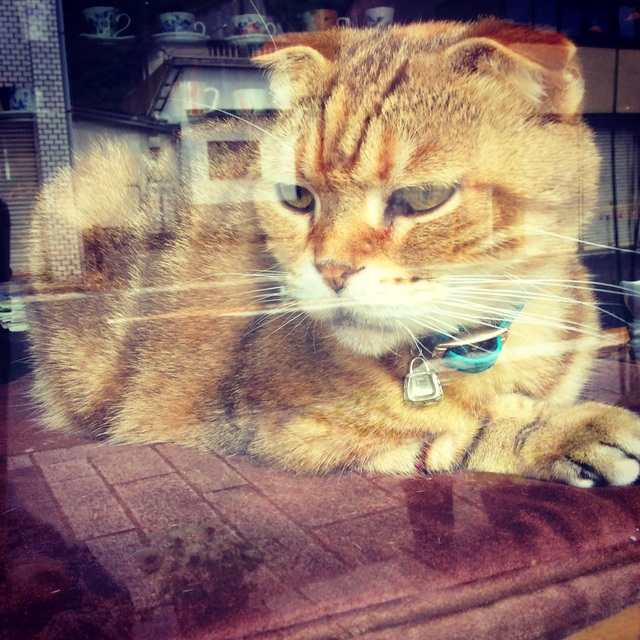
[252, 31, 338, 109]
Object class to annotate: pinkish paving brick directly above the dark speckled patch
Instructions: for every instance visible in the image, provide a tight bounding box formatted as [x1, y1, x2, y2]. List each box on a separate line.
[115, 473, 215, 532]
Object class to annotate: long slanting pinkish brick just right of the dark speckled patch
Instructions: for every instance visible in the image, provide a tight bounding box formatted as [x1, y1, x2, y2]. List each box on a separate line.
[206, 487, 343, 587]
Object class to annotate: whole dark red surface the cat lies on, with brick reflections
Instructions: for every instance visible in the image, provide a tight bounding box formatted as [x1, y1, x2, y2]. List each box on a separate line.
[0, 352, 640, 640]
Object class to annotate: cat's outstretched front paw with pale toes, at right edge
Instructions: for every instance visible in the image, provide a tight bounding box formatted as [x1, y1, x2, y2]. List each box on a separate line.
[516, 402, 640, 487]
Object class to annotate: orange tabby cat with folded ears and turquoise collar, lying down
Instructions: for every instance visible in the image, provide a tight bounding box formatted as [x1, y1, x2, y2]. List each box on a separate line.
[29, 18, 640, 487]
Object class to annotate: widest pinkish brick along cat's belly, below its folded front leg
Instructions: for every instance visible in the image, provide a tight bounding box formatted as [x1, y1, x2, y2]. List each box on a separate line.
[222, 458, 399, 527]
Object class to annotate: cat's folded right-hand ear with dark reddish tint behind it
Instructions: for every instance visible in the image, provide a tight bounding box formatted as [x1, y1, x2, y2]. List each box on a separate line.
[446, 19, 584, 115]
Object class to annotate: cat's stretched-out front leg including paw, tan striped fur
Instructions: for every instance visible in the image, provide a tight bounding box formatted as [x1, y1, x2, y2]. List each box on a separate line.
[465, 395, 640, 487]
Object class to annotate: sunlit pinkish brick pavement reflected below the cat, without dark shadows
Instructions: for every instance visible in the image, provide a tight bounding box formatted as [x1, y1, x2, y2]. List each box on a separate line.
[2, 350, 640, 640]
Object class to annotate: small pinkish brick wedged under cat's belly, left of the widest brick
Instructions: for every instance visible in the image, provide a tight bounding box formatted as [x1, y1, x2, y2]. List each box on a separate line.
[155, 444, 246, 493]
